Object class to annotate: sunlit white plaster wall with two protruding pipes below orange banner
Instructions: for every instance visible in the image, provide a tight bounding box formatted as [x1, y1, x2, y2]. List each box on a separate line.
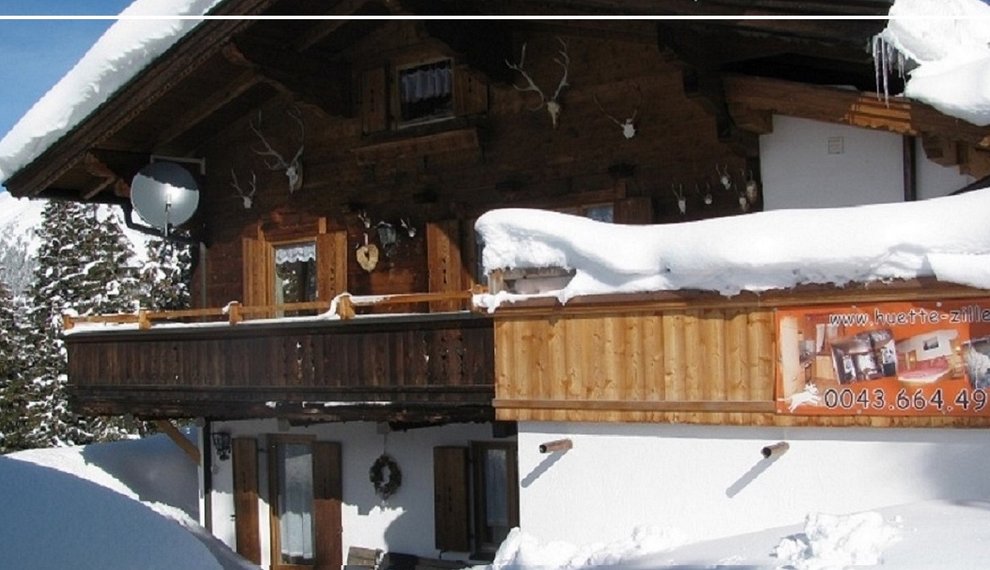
[518, 423, 990, 547]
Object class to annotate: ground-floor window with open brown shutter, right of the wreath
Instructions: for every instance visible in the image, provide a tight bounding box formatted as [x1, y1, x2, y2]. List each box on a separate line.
[433, 442, 519, 559]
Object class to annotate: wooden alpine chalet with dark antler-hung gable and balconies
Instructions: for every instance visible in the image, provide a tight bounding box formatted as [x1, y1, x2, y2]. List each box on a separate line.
[5, 0, 990, 568]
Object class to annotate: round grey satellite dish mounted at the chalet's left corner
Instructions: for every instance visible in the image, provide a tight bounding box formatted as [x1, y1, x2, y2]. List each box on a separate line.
[131, 162, 199, 231]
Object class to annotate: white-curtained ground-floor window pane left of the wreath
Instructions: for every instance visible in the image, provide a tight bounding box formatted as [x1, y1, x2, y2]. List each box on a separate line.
[278, 443, 314, 563]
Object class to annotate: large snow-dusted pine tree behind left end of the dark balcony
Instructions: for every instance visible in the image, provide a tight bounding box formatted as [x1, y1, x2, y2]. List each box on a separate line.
[26, 201, 146, 447]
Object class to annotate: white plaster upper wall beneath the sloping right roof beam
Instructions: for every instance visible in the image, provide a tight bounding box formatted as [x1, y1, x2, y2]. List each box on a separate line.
[760, 115, 973, 210]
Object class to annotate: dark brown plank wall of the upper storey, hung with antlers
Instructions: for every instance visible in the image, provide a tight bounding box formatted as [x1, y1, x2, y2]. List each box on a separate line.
[194, 21, 756, 306]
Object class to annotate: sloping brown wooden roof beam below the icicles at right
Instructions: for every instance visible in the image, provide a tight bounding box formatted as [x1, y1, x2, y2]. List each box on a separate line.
[723, 75, 990, 150]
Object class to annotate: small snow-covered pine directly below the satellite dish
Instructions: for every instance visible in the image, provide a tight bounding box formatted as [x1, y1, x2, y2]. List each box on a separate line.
[140, 232, 192, 311]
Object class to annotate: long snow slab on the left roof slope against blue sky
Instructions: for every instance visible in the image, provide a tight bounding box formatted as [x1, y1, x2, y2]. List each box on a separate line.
[0, 0, 220, 180]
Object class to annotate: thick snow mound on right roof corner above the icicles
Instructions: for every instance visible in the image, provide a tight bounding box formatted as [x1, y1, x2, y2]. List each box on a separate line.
[879, 0, 990, 126]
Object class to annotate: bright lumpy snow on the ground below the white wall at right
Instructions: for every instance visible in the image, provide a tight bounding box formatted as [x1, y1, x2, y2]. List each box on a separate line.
[477, 501, 990, 570]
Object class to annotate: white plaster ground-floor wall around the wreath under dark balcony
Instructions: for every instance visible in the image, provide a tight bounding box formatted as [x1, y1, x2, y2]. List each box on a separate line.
[212, 414, 504, 564]
